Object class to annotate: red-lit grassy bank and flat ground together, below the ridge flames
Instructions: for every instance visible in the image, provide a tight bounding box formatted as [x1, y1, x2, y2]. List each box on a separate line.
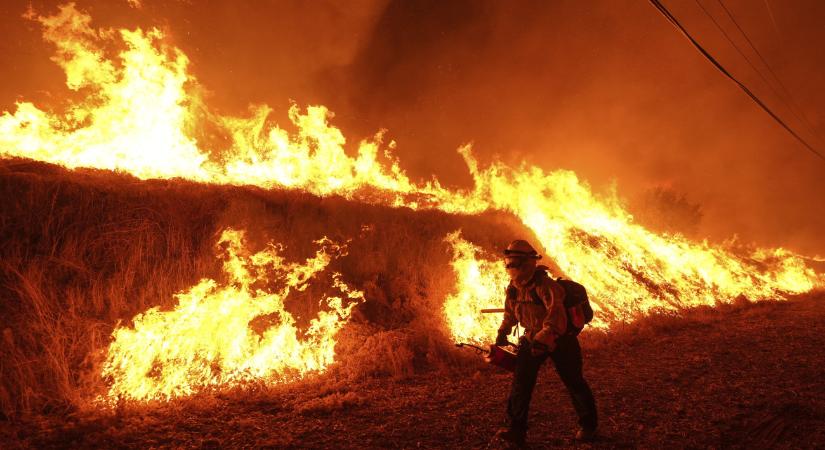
[0, 160, 825, 448]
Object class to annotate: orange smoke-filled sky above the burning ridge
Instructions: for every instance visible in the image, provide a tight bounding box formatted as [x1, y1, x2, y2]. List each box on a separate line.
[0, 0, 825, 254]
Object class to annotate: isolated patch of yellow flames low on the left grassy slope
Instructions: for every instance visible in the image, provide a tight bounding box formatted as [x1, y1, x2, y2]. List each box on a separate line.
[102, 229, 363, 402]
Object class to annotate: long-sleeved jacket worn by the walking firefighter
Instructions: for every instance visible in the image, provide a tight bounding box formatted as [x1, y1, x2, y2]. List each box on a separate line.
[499, 266, 567, 351]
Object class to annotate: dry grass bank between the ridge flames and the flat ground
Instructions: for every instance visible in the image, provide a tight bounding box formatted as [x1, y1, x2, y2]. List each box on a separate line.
[0, 160, 529, 418]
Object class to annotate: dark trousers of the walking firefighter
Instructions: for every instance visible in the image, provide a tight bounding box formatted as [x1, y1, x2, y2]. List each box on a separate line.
[507, 336, 596, 432]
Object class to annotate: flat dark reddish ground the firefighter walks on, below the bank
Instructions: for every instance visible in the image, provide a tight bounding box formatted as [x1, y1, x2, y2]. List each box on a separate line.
[0, 293, 825, 448]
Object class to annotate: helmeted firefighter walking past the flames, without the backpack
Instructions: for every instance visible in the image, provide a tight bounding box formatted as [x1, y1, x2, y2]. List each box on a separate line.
[493, 240, 596, 446]
